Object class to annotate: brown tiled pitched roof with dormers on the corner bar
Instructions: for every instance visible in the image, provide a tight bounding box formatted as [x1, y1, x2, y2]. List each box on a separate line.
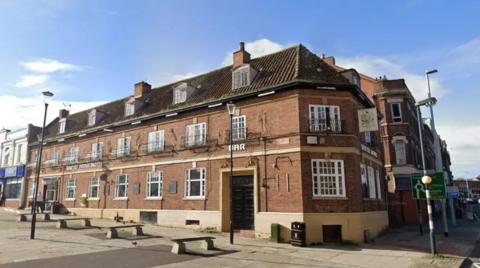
[42, 45, 356, 138]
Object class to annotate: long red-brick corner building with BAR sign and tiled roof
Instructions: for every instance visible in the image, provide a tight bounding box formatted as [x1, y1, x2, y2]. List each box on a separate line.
[29, 44, 388, 243]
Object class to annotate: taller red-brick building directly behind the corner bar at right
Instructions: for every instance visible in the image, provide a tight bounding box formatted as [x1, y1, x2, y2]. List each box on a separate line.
[323, 56, 438, 226]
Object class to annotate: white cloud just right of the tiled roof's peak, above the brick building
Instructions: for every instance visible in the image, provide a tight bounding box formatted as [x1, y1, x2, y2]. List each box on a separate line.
[336, 56, 447, 100]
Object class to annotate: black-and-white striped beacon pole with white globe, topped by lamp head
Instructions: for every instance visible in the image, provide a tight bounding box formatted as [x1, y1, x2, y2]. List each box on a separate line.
[416, 97, 437, 255]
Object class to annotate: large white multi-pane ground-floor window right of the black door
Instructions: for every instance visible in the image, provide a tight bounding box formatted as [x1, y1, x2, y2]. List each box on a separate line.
[312, 159, 346, 197]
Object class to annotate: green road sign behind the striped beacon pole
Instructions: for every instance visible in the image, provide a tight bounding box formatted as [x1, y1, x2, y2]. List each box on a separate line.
[412, 172, 447, 199]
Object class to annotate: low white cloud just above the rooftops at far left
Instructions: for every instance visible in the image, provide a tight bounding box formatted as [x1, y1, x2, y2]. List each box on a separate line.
[0, 96, 104, 129]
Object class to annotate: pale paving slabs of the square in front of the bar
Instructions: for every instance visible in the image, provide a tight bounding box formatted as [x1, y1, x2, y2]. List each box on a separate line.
[0, 209, 472, 268]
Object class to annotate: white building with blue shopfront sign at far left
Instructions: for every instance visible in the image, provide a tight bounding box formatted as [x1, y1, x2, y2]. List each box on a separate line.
[0, 125, 39, 208]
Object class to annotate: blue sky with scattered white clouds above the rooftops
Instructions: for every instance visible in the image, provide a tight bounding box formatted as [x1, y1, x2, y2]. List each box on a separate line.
[0, 0, 480, 177]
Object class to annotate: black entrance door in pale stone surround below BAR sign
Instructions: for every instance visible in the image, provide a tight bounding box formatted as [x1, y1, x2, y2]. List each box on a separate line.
[232, 176, 254, 230]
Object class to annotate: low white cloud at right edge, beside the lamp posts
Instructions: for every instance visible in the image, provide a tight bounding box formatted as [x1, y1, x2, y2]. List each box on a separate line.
[437, 125, 480, 178]
